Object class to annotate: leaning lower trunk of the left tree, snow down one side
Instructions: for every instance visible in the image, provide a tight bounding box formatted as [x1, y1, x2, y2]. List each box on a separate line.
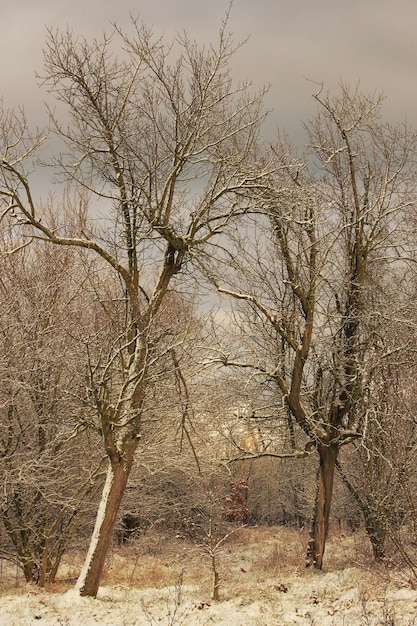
[75, 445, 136, 598]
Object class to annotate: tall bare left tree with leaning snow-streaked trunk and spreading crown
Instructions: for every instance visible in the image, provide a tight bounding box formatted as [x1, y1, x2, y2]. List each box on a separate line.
[0, 14, 262, 596]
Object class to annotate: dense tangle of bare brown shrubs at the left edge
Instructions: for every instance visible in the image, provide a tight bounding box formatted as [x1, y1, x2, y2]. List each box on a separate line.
[0, 238, 100, 586]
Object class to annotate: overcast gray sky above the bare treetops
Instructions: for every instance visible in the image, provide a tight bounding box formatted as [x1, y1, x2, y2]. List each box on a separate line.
[0, 0, 417, 142]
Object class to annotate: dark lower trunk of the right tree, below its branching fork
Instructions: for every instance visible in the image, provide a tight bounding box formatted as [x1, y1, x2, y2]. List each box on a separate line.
[306, 444, 339, 569]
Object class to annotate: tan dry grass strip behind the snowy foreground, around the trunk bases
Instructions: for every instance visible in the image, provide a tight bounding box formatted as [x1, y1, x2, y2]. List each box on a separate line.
[0, 527, 412, 601]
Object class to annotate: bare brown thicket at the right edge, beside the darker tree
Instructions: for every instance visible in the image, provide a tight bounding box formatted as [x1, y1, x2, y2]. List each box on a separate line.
[338, 270, 416, 560]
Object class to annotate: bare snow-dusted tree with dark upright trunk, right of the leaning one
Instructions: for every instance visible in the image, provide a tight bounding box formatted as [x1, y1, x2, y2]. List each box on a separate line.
[210, 85, 416, 568]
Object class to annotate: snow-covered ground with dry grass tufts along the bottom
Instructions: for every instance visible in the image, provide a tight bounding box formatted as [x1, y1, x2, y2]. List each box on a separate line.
[0, 529, 417, 626]
